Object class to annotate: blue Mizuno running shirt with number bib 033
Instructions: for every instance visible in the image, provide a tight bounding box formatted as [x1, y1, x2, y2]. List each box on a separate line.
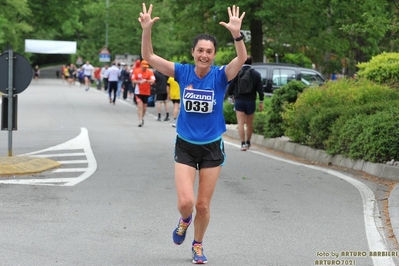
[175, 63, 228, 144]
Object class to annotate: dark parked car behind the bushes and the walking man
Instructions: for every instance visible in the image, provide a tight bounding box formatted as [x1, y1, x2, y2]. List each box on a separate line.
[252, 63, 326, 95]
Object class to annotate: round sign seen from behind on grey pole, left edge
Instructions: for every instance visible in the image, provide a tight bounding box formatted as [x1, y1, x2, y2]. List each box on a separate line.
[0, 49, 33, 156]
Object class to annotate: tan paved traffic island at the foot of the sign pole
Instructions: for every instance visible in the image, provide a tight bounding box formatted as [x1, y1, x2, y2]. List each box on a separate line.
[0, 156, 61, 177]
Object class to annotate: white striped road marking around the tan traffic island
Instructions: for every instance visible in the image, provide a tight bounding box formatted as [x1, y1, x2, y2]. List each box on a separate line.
[0, 128, 97, 186]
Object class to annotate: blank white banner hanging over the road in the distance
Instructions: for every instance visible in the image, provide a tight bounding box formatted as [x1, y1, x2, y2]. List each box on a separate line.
[25, 40, 76, 54]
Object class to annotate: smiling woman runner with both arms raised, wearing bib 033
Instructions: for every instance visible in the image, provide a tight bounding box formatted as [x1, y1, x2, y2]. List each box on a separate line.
[138, 3, 247, 264]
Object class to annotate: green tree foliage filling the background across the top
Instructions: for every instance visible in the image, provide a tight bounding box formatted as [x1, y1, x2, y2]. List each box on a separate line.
[0, 0, 399, 73]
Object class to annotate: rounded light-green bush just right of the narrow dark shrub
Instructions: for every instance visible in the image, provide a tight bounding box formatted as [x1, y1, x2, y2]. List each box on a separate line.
[282, 79, 399, 148]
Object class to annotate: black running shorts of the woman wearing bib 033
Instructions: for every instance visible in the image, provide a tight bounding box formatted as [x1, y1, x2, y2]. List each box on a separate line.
[175, 136, 226, 170]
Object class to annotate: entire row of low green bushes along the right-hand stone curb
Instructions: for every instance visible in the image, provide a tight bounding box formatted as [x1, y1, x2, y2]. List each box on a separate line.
[224, 64, 399, 163]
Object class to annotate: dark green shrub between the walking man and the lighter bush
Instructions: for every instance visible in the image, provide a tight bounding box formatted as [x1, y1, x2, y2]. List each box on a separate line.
[263, 80, 306, 138]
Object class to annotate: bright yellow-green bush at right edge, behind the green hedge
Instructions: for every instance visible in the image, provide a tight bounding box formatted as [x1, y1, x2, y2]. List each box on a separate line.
[357, 52, 399, 87]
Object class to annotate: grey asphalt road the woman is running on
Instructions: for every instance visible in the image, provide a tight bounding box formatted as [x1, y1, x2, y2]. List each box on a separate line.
[0, 80, 399, 266]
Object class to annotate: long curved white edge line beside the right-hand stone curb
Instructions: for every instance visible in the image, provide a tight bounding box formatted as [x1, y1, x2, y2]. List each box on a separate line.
[225, 141, 395, 266]
